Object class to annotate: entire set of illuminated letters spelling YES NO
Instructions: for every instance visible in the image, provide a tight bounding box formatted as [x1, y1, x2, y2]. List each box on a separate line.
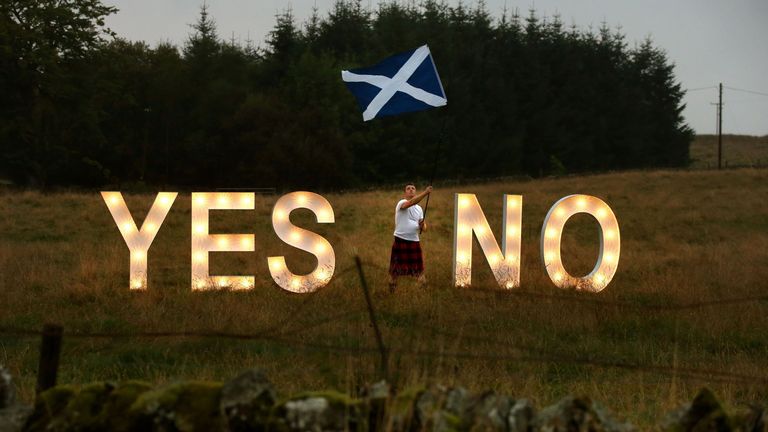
[101, 192, 621, 293]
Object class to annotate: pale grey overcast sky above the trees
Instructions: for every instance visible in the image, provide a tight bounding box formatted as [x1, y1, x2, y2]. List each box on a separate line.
[104, 0, 768, 135]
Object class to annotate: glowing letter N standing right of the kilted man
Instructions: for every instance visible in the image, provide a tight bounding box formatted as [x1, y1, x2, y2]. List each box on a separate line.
[453, 194, 523, 288]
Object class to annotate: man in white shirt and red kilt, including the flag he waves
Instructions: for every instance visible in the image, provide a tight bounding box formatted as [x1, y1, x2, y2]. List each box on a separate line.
[341, 45, 448, 292]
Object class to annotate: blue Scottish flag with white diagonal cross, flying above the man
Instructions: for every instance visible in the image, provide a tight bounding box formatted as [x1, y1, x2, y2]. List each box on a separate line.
[341, 45, 448, 121]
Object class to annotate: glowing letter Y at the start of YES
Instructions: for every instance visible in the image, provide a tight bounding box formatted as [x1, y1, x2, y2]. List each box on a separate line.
[101, 192, 178, 290]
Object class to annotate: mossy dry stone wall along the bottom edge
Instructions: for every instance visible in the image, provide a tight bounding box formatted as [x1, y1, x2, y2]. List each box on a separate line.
[0, 367, 768, 432]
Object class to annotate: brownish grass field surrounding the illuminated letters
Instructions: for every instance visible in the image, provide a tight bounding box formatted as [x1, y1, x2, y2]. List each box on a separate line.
[0, 169, 768, 425]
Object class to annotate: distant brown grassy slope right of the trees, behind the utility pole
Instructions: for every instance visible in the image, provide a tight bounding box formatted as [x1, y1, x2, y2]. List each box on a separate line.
[691, 135, 768, 168]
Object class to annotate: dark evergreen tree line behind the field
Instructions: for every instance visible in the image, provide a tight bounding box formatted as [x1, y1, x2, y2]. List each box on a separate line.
[0, 0, 693, 189]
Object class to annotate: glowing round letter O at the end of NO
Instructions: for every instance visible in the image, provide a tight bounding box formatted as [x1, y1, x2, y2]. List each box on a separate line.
[541, 195, 621, 292]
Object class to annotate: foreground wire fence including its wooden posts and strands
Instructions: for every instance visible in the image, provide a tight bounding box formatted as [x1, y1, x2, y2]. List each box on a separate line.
[0, 263, 768, 391]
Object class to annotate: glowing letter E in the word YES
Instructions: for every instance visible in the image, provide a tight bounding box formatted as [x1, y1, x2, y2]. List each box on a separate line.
[192, 192, 255, 290]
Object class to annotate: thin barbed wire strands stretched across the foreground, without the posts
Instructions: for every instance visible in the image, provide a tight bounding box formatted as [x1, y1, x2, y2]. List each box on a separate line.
[0, 262, 768, 385]
